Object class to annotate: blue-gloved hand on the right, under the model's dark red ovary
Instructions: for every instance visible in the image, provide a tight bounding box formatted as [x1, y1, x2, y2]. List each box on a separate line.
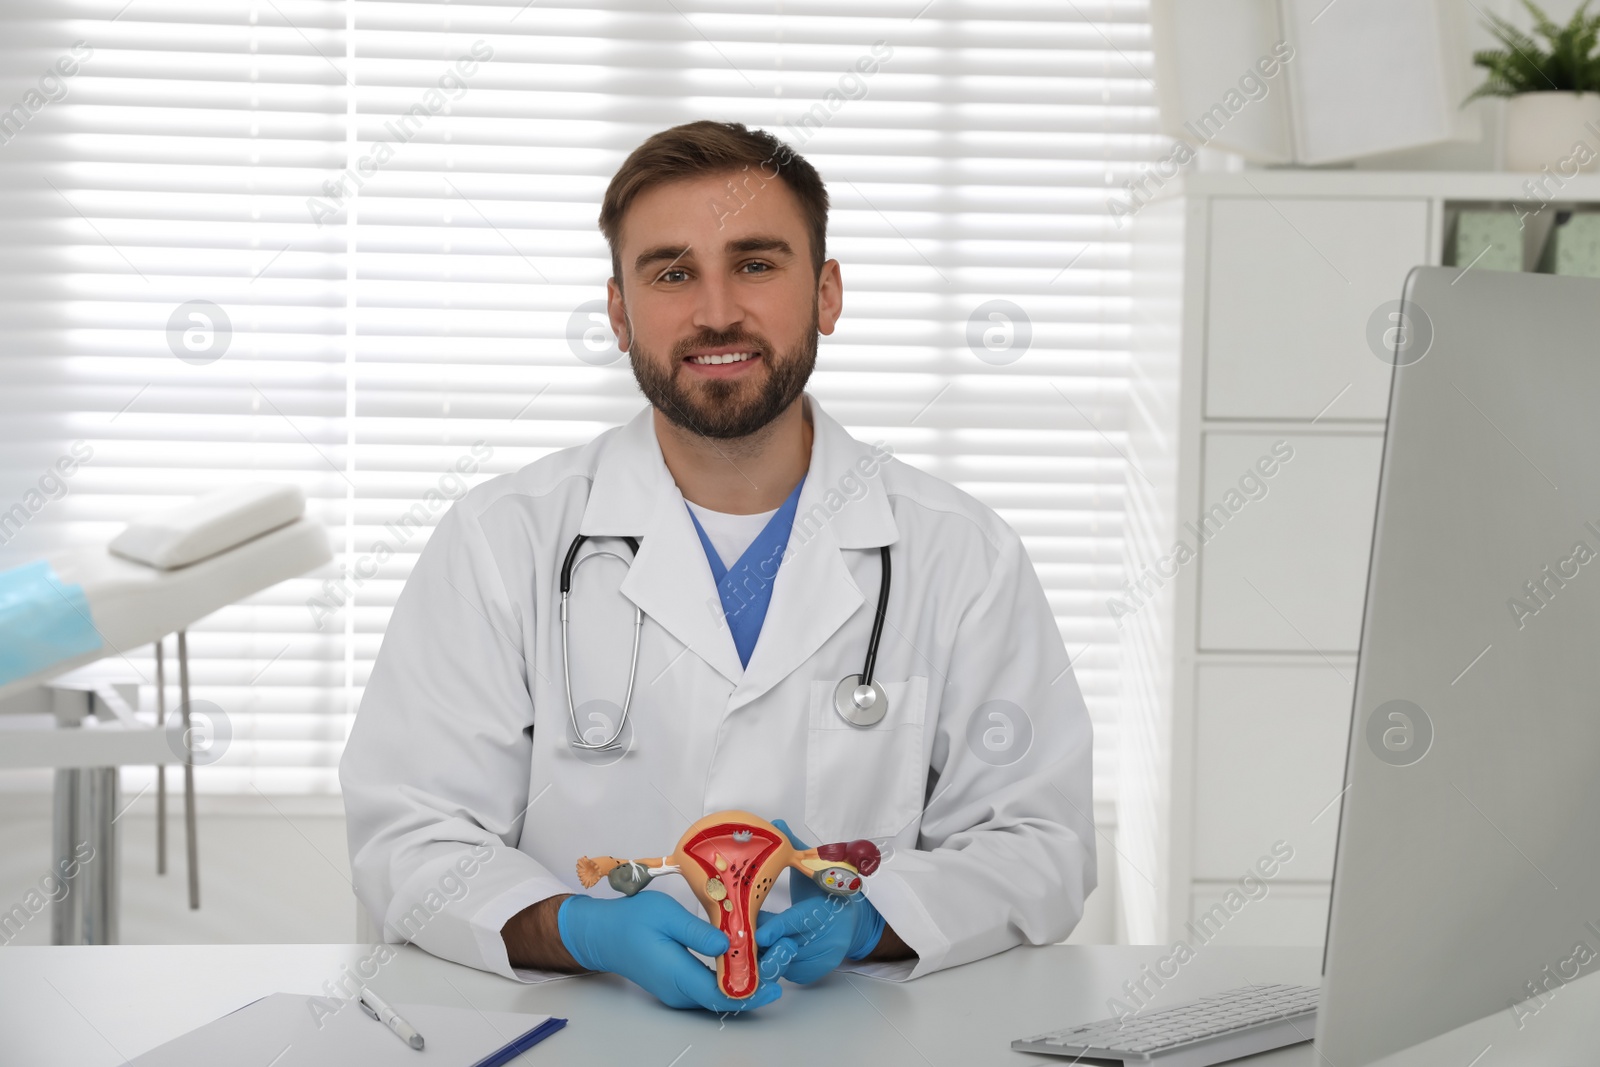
[755, 819, 885, 985]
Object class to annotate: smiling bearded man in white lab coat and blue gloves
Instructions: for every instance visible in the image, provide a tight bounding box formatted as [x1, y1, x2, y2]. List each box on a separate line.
[339, 122, 1096, 1011]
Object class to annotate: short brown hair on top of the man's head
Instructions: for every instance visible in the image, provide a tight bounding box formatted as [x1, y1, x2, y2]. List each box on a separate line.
[600, 118, 827, 285]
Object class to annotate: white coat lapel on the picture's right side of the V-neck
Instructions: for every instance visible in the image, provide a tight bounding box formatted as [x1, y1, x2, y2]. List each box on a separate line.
[730, 395, 898, 710]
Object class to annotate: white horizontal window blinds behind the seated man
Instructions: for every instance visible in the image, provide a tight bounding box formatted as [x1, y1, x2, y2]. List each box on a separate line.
[0, 0, 1165, 797]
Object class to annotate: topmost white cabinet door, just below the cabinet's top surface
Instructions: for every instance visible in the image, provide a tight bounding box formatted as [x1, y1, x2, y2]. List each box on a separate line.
[1205, 195, 1429, 419]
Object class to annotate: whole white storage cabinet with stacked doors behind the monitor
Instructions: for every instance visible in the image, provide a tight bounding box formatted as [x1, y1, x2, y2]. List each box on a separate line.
[1102, 170, 1600, 944]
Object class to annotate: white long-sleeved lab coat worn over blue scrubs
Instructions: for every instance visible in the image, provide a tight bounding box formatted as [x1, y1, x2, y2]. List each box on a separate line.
[339, 397, 1096, 981]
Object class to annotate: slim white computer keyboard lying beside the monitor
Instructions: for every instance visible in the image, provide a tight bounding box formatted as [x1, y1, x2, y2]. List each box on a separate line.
[1011, 985, 1317, 1067]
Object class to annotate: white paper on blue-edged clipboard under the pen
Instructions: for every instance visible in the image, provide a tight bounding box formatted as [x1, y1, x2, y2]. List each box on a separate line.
[130, 993, 563, 1067]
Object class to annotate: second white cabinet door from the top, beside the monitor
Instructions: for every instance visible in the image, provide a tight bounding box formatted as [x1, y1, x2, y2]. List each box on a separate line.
[1190, 429, 1382, 653]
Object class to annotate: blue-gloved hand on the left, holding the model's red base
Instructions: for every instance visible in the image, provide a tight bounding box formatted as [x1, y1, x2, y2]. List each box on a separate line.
[555, 889, 782, 1011]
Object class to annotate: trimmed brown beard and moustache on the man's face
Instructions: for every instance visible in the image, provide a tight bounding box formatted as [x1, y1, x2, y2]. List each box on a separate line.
[627, 301, 818, 440]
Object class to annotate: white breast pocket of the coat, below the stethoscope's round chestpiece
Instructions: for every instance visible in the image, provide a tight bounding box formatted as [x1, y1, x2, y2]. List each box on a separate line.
[797, 678, 928, 846]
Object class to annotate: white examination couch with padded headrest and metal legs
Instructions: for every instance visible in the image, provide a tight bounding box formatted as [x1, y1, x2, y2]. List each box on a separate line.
[0, 483, 333, 944]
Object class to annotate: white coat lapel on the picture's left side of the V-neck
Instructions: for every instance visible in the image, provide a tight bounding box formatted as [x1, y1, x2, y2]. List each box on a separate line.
[579, 408, 744, 685]
